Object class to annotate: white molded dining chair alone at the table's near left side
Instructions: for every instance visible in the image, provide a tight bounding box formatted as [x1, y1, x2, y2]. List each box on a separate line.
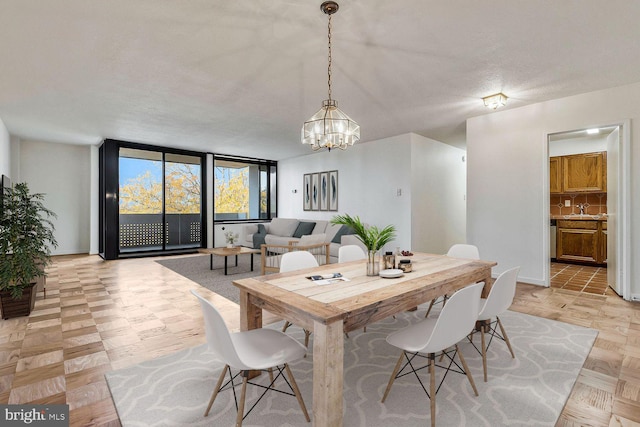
[191, 290, 311, 427]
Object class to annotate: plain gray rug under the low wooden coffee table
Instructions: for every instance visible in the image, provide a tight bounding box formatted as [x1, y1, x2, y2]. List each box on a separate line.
[156, 254, 260, 304]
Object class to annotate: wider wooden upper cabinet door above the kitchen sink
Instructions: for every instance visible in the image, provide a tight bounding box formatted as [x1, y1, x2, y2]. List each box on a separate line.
[561, 152, 607, 193]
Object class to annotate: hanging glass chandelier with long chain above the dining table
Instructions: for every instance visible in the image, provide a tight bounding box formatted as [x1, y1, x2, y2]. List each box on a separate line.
[302, 1, 360, 151]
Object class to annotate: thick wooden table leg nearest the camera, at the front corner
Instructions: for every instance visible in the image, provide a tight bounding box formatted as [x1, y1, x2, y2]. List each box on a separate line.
[313, 320, 344, 427]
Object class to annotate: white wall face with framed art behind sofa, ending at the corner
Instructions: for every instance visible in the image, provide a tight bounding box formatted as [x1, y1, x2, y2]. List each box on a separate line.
[278, 134, 411, 250]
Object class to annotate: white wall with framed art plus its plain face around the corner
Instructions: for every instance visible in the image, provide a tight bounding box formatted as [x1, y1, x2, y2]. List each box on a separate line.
[278, 134, 466, 253]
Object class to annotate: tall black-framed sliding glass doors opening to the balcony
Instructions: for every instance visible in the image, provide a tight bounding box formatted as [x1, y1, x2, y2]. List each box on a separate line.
[100, 140, 205, 259]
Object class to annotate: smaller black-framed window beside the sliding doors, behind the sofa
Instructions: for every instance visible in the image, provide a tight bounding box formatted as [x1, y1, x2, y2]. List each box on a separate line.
[213, 155, 277, 221]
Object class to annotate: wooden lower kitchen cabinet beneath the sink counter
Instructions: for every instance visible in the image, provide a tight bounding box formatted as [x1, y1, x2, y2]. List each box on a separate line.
[556, 220, 607, 265]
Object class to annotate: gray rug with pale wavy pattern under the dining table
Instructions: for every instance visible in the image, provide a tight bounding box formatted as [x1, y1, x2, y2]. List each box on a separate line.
[106, 306, 597, 427]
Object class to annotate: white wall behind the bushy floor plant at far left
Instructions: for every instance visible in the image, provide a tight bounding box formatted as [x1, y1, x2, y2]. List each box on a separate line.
[17, 140, 91, 255]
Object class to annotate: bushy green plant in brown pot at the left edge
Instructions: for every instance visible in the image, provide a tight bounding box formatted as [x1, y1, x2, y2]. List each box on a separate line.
[0, 183, 58, 319]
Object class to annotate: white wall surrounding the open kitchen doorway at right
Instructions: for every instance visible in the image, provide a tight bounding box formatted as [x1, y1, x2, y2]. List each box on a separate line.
[467, 83, 640, 297]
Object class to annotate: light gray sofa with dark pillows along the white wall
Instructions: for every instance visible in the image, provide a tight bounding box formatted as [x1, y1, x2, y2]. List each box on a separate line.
[241, 218, 364, 262]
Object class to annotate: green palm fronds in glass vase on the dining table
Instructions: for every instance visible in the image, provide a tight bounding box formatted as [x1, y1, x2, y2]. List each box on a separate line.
[331, 214, 396, 276]
